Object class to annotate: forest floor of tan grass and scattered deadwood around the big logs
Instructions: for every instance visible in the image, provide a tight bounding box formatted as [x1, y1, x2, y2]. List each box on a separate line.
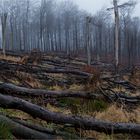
[0, 51, 140, 140]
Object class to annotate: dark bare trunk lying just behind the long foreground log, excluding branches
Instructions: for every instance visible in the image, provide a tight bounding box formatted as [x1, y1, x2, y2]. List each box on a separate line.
[0, 83, 103, 99]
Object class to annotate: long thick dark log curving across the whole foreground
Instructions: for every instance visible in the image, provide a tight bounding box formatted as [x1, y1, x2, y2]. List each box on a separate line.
[0, 94, 140, 135]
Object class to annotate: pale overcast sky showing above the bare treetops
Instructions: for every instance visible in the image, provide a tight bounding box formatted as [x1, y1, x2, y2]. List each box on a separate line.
[72, 0, 140, 17]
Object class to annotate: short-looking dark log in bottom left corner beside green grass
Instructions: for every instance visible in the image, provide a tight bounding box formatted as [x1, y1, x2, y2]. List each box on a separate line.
[0, 115, 56, 139]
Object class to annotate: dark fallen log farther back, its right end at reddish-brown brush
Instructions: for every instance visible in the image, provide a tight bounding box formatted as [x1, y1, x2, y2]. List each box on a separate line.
[0, 61, 124, 80]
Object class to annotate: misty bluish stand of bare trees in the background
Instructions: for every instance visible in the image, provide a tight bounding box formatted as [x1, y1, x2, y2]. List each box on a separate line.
[0, 0, 140, 66]
